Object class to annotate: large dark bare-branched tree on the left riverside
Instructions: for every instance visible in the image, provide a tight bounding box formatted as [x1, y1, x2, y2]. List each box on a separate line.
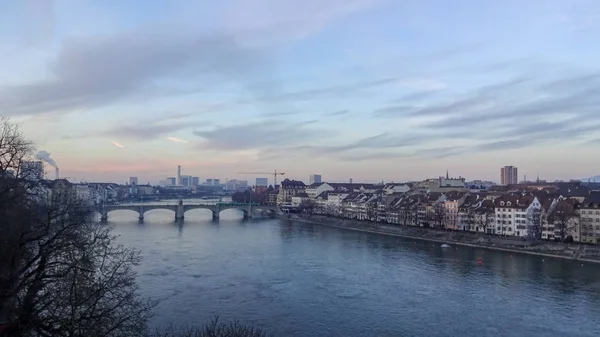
[0, 119, 153, 336]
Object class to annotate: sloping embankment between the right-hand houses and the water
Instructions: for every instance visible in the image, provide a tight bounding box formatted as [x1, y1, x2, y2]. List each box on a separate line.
[286, 214, 600, 264]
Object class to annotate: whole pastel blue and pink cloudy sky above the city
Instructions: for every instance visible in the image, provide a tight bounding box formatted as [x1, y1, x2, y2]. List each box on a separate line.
[0, 0, 600, 183]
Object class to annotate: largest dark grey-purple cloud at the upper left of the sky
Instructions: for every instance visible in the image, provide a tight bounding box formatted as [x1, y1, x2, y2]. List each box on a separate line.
[0, 30, 284, 115]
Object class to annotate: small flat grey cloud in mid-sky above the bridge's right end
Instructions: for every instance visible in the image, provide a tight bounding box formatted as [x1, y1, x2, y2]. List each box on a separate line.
[194, 120, 334, 151]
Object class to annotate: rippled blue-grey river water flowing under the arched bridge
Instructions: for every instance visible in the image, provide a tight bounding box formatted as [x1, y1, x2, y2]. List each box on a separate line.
[109, 210, 600, 337]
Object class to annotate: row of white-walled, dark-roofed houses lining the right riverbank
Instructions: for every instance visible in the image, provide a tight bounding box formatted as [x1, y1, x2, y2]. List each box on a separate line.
[276, 178, 600, 243]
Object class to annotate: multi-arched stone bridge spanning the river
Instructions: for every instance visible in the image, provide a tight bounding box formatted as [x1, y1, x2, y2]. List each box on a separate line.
[98, 200, 281, 221]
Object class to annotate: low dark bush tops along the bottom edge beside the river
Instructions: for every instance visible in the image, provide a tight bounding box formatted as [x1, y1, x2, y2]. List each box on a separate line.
[149, 316, 271, 337]
